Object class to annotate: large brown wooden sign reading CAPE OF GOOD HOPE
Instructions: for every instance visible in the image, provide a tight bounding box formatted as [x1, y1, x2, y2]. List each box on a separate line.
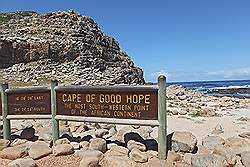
[56, 86, 158, 120]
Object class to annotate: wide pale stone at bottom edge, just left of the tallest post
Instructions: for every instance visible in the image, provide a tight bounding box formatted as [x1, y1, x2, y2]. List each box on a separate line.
[99, 156, 136, 167]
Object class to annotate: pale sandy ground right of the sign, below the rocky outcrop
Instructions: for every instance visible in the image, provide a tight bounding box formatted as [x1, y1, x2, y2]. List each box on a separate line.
[167, 109, 250, 144]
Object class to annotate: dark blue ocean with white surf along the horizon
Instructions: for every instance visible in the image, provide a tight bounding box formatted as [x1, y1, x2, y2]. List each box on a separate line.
[167, 80, 250, 98]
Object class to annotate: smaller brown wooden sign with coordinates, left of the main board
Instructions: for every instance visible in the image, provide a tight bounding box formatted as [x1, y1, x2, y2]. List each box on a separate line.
[7, 88, 51, 115]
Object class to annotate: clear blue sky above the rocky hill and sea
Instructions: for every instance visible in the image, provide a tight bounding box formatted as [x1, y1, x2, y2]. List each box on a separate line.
[0, 0, 250, 82]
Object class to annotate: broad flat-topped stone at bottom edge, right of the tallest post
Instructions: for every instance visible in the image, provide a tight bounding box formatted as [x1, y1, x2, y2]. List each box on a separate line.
[191, 154, 228, 167]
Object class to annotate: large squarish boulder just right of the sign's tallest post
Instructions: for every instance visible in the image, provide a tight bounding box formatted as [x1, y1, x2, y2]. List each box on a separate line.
[172, 132, 197, 152]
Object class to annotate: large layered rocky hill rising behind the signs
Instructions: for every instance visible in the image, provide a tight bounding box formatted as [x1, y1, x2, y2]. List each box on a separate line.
[0, 11, 144, 85]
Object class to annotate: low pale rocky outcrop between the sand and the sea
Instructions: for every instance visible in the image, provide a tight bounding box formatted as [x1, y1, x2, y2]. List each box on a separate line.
[167, 85, 250, 116]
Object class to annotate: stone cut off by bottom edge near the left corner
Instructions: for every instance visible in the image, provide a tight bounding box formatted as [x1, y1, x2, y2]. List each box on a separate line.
[8, 158, 37, 167]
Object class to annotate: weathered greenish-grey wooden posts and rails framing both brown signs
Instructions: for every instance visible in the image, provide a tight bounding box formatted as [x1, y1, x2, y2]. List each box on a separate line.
[0, 75, 167, 159]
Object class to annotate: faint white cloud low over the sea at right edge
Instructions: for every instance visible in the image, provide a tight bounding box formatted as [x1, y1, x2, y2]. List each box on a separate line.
[208, 67, 250, 78]
